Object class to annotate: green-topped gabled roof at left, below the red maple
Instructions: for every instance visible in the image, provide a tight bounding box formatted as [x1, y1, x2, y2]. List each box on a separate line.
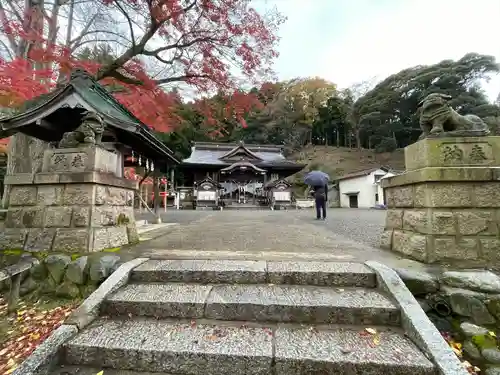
[0, 69, 179, 164]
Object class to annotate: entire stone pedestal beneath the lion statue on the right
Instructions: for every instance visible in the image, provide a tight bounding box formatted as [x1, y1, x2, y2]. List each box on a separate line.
[381, 137, 500, 265]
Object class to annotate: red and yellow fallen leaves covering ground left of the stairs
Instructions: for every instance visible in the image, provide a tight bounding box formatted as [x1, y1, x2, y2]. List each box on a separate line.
[0, 298, 76, 375]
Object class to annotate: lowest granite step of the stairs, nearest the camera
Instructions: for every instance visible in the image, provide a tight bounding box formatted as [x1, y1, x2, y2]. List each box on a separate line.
[63, 319, 436, 375]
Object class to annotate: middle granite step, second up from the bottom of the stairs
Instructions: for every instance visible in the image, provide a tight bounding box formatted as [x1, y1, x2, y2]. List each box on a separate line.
[101, 283, 401, 326]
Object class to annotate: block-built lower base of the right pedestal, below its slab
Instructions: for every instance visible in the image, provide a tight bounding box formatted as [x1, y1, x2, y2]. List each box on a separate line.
[381, 182, 500, 266]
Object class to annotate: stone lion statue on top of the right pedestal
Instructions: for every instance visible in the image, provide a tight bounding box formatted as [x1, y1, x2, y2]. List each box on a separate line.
[418, 93, 490, 139]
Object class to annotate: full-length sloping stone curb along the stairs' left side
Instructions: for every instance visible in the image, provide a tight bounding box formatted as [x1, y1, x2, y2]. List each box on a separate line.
[13, 258, 149, 375]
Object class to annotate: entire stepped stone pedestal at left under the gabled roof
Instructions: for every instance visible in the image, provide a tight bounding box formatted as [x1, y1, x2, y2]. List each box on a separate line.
[0, 146, 138, 253]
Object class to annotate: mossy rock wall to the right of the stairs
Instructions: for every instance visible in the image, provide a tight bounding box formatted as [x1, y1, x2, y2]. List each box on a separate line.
[396, 268, 500, 374]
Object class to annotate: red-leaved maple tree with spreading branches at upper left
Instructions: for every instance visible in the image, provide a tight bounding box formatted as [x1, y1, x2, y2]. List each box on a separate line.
[0, 0, 284, 132]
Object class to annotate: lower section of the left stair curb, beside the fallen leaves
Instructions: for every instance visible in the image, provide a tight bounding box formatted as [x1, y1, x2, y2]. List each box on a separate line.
[12, 324, 78, 375]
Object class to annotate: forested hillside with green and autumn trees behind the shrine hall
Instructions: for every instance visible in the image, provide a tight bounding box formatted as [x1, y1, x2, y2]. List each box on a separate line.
[161, 53, 500, 167]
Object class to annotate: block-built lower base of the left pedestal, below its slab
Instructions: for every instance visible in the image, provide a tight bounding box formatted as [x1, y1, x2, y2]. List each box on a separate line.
[0, 184, 137, 252]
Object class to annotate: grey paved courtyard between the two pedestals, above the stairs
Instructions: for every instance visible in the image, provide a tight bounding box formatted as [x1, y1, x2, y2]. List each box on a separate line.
[130, 209, 397, 261]
